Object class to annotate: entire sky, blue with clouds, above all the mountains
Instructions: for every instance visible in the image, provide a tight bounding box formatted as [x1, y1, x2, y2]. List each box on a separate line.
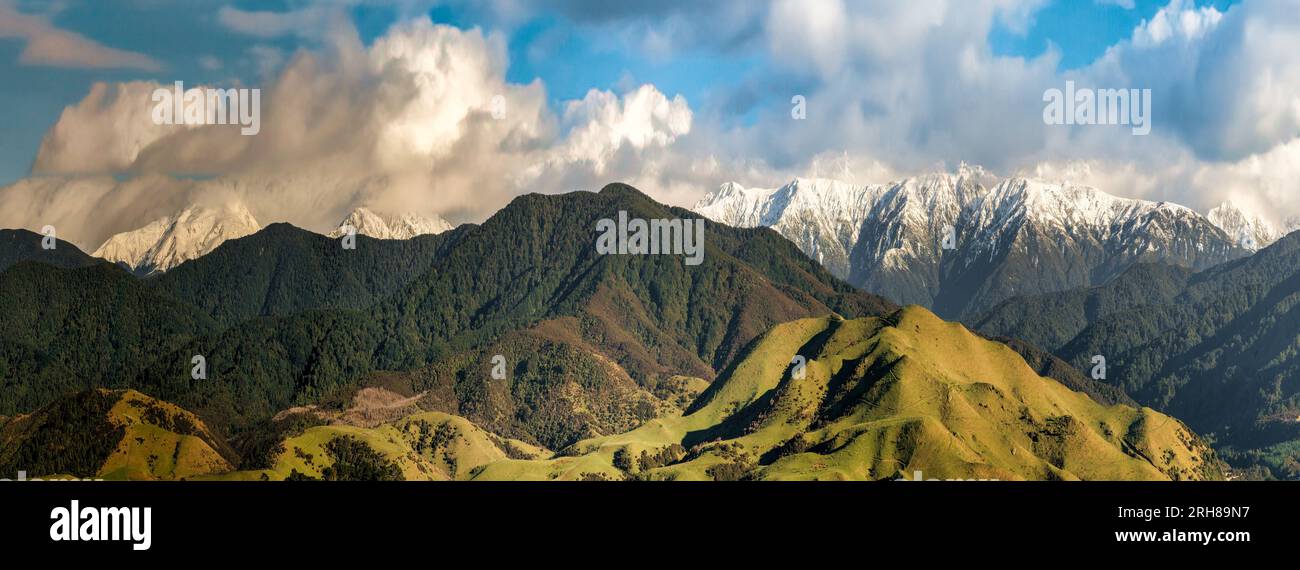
[0, 0, 1300, 247]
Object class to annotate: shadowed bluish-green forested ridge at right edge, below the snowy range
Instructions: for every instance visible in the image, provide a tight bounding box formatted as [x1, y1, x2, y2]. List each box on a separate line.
[979, 233, 1300, 473]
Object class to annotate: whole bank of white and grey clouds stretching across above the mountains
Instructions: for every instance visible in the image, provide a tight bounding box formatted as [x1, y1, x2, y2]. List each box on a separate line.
[0, 0, 1300, 249]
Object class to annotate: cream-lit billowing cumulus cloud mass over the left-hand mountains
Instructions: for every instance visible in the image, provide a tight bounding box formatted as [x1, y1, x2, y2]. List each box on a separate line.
[0, 18, 692, 247]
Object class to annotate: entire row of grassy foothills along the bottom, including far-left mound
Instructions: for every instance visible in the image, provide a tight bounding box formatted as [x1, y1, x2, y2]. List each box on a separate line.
[12, 307, 1222, 480]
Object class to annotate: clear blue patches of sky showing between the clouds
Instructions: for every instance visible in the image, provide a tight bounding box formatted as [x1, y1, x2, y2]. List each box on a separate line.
[0, 0, 1232, 183]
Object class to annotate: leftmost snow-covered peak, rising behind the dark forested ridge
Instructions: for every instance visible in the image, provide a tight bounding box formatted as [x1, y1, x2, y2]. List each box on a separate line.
[94, 204, 261, 275]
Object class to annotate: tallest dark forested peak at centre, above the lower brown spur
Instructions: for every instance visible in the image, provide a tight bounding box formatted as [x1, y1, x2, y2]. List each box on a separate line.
[377, 185, 892, 367]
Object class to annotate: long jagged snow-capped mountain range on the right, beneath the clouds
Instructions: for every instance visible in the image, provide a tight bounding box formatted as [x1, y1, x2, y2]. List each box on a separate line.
[694, 165, 1263, 319]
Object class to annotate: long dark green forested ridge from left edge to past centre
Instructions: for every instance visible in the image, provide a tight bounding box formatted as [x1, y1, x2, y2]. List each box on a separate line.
[0, 185, 893, 445]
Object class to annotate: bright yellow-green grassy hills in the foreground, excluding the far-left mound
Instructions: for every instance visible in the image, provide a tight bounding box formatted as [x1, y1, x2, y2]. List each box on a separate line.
[226, 307, 1223, 480]
